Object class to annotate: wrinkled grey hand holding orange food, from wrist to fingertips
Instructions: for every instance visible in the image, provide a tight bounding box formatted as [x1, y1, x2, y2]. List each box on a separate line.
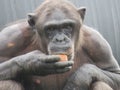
[12, 50, 73, 76]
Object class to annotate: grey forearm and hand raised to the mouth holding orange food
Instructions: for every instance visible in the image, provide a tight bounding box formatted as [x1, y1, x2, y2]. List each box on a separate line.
[0, 50, 73, 80]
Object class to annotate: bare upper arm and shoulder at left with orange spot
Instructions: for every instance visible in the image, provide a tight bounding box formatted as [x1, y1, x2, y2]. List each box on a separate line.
[0, 23, 34, 58]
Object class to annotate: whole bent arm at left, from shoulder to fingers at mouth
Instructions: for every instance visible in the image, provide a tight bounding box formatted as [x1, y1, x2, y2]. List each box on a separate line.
[0, 26, 73, 80]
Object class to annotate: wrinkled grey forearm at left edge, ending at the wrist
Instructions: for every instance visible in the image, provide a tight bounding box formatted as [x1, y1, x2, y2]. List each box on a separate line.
[0, 57, 22, 80]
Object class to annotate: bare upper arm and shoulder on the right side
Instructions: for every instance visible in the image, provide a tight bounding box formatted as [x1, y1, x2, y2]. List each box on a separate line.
[81, 27, 120, 73]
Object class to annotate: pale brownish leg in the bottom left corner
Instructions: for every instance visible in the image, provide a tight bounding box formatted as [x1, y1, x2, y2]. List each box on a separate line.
[0, 80, 24, 90]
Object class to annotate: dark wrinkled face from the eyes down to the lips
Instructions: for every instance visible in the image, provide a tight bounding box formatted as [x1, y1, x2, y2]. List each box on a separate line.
[45, 20, 74, 59]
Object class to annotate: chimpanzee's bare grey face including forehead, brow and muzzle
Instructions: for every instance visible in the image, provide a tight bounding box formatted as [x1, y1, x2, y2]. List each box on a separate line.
[36, 9, 80, 60]
